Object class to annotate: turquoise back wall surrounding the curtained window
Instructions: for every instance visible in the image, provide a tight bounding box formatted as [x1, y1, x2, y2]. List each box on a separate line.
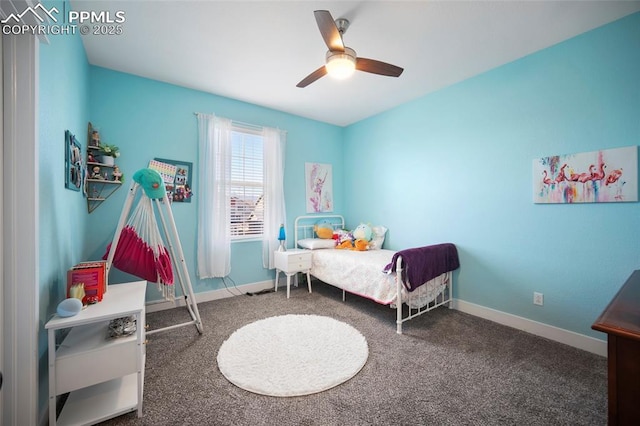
[86, 67, 344, 299]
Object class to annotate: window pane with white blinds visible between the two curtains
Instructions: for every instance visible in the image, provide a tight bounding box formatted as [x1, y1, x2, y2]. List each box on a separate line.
[230, 126, 264, 240]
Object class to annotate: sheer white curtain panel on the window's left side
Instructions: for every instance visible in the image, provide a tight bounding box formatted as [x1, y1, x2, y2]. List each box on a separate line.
[196, 113, 231, 278]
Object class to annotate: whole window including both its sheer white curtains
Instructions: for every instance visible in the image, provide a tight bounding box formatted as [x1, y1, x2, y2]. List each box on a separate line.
[196, 113, 286, 279]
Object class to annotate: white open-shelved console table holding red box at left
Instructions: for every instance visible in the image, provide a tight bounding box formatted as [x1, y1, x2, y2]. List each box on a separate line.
[45, 281, 147, 426]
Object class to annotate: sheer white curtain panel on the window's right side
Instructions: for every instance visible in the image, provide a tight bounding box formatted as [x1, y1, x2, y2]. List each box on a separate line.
[262, 128, 288, 269]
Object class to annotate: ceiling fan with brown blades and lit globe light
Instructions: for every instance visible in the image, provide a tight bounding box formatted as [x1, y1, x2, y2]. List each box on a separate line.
[296, 10, 404, 87]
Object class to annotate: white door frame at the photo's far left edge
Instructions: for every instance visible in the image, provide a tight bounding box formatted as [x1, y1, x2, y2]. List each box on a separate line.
[0, 0, 46, 426]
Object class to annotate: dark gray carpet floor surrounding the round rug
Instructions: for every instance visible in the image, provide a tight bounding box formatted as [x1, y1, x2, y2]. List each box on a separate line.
[97, 282, 607, 426]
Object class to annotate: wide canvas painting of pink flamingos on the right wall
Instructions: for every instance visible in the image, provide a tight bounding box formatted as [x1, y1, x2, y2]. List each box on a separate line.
[533, 146, 638, 203]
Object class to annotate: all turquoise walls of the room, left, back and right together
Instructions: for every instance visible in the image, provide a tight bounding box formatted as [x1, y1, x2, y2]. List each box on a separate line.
[37, 6, 640, 422]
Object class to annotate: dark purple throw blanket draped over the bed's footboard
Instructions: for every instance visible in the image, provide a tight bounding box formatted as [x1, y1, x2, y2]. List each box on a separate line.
[384, 243, 460, 291]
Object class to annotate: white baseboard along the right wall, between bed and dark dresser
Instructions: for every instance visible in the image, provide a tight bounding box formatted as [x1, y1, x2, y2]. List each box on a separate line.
[453, 299, 607, 357]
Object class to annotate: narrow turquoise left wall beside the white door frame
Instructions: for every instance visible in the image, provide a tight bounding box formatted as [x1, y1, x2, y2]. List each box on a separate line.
[38, 2, 89, 414]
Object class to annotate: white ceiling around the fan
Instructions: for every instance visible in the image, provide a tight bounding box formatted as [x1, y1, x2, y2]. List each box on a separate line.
[71, 0, 640, 126]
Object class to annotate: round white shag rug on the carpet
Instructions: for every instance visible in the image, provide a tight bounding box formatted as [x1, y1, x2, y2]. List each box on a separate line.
[218, 315, 369, 396]
